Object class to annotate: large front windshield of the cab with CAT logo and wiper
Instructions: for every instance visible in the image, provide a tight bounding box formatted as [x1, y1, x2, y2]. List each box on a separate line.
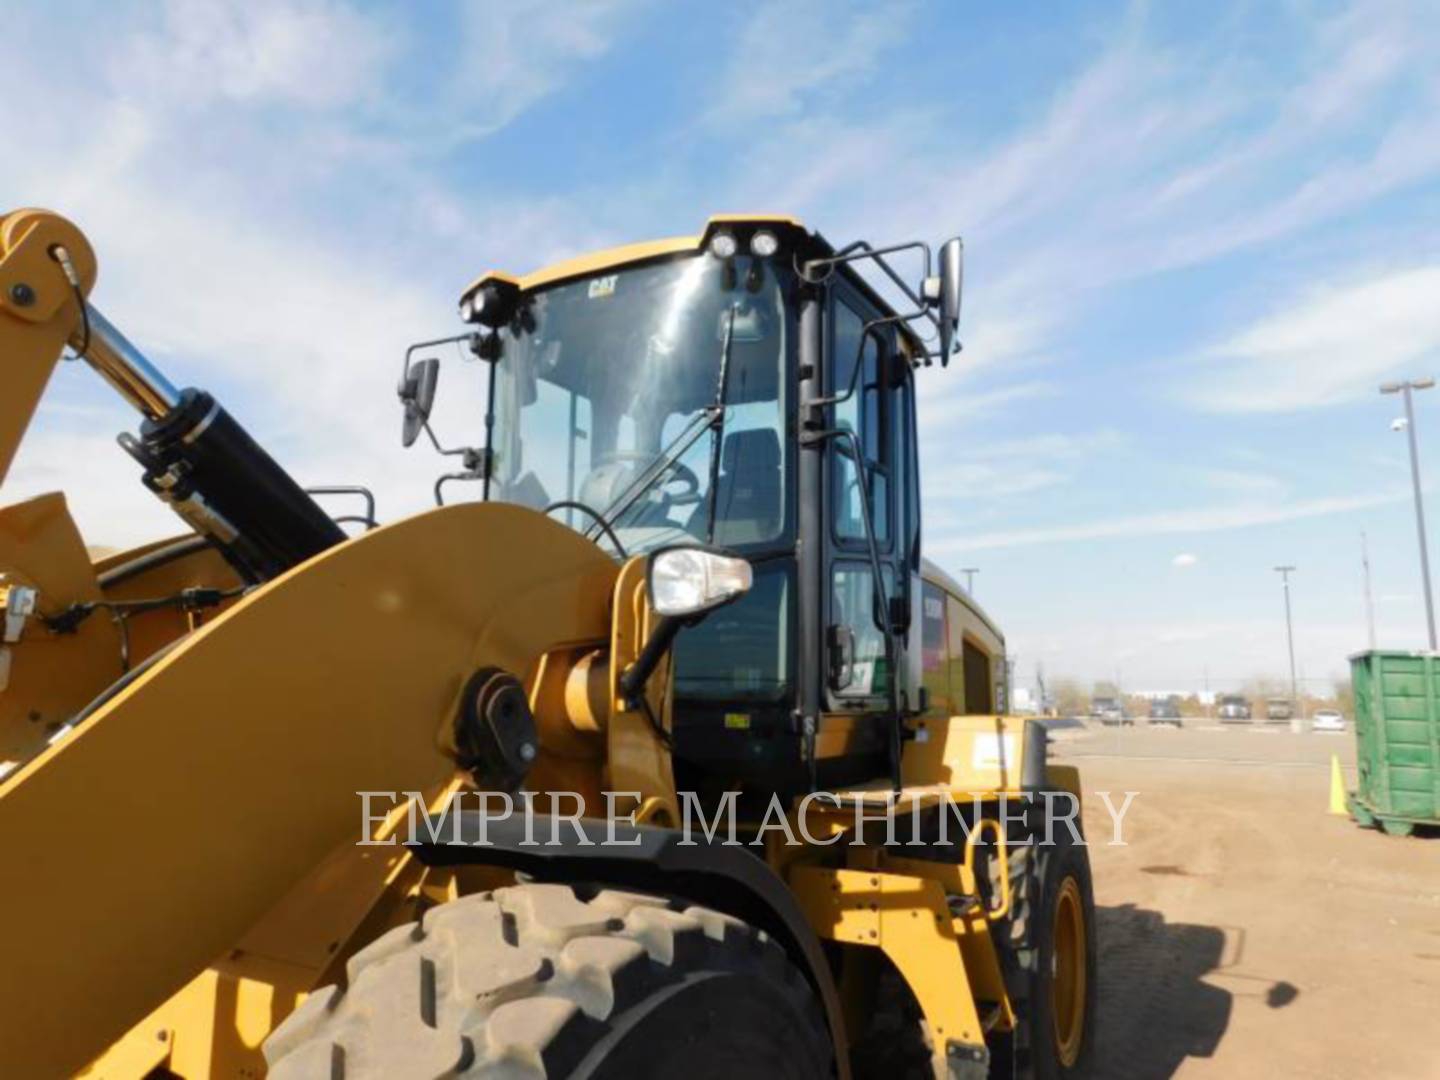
[491, 253, 791, 554]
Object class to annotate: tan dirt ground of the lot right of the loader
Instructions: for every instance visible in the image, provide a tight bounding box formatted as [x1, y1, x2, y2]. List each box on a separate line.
[1056, 723, 1440, 1080]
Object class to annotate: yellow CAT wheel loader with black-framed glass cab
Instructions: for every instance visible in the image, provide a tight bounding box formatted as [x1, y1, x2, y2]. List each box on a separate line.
[0, 210, 1096, 1080]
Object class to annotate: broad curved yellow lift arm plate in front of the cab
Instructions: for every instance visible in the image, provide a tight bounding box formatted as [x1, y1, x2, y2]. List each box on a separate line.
[0, 504, 616, 1077]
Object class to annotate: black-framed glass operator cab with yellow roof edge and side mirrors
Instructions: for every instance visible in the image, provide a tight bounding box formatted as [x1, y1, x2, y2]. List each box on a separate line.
[402, 217, 959, 791]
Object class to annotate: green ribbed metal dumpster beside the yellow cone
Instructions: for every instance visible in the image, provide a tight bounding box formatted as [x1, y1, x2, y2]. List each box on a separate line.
[1348, 651, 1440, 835]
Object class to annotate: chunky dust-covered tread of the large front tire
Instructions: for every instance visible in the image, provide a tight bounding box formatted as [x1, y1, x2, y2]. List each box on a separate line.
[265, 883, 828, 1080]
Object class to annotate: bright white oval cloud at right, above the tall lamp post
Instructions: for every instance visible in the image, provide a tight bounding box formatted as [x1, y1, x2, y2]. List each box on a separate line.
[1184, 265, 1440, 412]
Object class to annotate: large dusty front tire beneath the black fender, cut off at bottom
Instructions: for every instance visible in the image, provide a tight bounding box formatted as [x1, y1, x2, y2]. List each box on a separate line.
[265, 884, 832, 1080]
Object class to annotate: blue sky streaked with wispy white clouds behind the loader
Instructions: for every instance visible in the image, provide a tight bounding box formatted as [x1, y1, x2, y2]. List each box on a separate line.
[0, 0, 1440, 687]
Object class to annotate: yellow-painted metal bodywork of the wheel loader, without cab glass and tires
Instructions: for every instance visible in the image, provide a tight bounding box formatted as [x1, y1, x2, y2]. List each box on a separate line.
[0, 210, 1079, 1080]
